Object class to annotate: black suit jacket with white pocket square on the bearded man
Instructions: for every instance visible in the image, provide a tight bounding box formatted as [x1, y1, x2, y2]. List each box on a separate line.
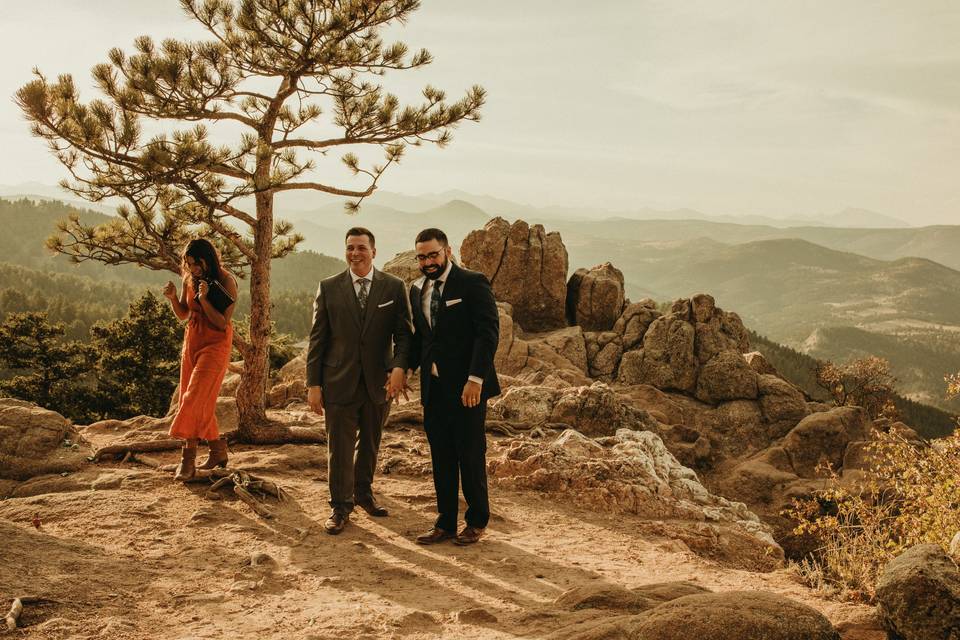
[409, 264, 500, 405]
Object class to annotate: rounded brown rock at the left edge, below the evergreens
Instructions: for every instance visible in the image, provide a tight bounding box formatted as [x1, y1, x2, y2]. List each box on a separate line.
[0, 398, 91, 480]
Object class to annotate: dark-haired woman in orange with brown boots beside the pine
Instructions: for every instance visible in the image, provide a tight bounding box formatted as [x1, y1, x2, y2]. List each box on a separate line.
[163, 238, 237, 482]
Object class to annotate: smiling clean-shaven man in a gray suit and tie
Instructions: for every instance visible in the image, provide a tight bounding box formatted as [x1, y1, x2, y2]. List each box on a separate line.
[307, 227, 412, 534]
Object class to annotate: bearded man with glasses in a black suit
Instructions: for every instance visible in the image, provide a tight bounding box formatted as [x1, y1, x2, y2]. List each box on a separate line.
[410, 229, 500, 544]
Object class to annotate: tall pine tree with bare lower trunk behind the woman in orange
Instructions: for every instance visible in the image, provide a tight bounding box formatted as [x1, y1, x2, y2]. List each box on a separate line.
[16, 0, 484, 442]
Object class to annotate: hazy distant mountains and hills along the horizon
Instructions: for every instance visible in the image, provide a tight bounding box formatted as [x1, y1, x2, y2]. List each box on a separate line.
[0, 193, 960, 411]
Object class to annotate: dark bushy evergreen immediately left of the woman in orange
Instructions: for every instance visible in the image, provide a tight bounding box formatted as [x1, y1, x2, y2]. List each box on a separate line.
[90, 291, 183, 418]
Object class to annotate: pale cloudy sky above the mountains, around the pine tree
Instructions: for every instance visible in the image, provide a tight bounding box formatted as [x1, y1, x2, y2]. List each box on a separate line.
[0, 0, 960, 225]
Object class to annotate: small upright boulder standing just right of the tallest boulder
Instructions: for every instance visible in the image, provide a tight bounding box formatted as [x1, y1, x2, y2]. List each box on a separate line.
[566, 262, 625, 331]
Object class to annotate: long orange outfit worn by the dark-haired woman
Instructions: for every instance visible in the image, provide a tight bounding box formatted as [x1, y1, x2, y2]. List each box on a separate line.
[170, 284, 233, 440]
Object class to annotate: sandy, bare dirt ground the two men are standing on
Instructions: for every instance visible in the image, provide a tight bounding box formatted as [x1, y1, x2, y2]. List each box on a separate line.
[0, 422, 885, 640]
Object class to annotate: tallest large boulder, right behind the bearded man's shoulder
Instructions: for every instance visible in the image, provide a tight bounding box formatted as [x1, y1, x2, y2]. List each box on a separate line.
[460, 217, 567, 331]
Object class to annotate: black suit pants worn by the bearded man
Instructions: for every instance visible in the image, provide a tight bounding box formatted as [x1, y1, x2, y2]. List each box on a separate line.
[423, 378, 490, 531]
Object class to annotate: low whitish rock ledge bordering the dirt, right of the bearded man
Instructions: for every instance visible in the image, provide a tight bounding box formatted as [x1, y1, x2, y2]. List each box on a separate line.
[488, 429, 783, 570]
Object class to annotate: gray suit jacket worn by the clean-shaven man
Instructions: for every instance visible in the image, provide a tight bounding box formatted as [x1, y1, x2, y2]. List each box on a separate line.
[307, 269, 412, 404]
